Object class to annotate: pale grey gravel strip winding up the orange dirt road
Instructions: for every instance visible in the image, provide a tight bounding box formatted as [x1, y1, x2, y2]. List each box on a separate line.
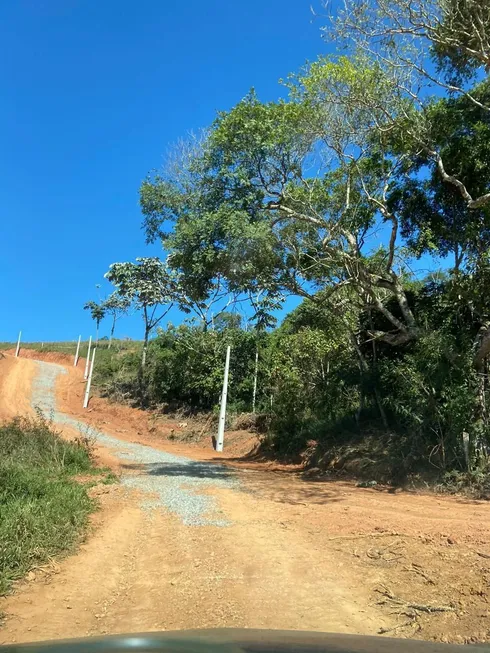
[31, 361, 238, 526]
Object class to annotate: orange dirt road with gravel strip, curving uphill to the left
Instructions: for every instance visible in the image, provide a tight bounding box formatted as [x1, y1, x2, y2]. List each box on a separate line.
[0, 358, 490, 643]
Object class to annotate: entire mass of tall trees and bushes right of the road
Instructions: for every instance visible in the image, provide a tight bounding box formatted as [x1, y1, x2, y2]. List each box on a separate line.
[128, 0, 490, 478]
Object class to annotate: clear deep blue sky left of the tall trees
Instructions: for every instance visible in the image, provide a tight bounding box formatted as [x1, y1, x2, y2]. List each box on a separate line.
[0, 0, 334, 340]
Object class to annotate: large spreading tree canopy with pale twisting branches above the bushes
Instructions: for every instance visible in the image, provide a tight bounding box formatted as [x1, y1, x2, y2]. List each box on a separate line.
[141, 0, 490, 454]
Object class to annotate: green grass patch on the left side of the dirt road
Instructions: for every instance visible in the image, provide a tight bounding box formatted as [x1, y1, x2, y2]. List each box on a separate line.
[0, 416, 95, 595]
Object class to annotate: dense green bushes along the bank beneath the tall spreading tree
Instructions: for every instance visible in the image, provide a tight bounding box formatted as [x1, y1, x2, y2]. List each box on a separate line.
[84, 278, 486, 482]
